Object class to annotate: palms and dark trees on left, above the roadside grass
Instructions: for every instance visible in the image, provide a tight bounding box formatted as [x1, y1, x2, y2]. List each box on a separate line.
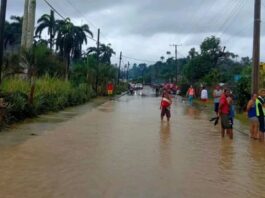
[1, 11, 118, 94]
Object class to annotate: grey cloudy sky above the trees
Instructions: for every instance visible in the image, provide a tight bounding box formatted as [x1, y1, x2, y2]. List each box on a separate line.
[3, 0, 265, 64]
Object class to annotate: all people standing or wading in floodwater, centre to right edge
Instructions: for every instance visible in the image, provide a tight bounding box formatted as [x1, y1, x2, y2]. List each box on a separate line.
[160, 86, 265, 141]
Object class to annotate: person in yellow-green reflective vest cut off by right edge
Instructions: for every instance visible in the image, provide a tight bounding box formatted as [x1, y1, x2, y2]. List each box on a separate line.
[256, 89, 265, 142]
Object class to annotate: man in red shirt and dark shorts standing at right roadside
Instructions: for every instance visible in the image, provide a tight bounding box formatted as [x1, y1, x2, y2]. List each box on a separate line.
[218, 89, 233, 139]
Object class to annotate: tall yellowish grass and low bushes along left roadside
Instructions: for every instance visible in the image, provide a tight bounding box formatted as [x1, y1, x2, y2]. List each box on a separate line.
[1, 76, 95, 123]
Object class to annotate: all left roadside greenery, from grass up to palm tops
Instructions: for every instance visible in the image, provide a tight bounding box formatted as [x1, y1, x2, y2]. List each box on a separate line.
[0, 11, 127, 127]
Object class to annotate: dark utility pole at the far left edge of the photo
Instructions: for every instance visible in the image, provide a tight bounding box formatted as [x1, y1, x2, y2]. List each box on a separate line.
[0, 0, 7, 83]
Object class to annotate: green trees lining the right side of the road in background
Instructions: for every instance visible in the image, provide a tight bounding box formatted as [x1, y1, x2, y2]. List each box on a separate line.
[129, 36, 251, 109]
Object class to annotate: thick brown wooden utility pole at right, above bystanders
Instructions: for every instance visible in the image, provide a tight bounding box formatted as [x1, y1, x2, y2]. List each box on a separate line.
[252, 0, 261, 93]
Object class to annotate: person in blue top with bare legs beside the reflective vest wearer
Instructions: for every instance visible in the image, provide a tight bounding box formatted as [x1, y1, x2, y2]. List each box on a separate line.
[247, 94, 259, 139]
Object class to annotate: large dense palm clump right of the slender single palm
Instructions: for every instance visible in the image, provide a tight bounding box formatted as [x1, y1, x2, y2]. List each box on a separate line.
[56, 18, 93, 80]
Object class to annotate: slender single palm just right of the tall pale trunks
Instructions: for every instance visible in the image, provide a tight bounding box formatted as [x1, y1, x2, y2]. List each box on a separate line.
[35, 10, 57, 49]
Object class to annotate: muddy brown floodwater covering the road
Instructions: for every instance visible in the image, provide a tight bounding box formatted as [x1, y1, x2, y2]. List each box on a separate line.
[0, 89, 265, 198]
